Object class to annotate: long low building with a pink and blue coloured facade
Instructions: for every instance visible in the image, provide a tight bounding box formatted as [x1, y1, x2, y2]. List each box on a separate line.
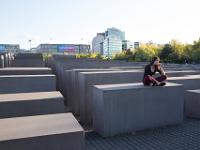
[36, 44, 90, 54]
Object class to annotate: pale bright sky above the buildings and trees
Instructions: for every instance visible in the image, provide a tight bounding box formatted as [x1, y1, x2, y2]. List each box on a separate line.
[0, 0, 200, 49]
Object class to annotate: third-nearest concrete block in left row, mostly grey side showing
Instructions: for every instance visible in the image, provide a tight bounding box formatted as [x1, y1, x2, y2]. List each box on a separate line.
[0, 75, 56, 94]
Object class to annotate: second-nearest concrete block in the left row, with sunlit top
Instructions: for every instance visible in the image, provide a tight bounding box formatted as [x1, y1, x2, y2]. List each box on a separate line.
[0, 91, 65, 119]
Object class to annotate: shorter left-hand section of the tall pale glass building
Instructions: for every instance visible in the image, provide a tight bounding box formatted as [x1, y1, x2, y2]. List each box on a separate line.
[92, 33, 105, 55]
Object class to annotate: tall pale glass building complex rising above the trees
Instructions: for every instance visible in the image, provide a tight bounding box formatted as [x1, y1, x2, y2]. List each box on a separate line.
[92, 28, 125, 57]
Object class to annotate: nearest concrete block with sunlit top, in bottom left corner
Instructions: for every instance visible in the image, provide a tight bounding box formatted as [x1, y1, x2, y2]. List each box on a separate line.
[0, 113, 85, 150]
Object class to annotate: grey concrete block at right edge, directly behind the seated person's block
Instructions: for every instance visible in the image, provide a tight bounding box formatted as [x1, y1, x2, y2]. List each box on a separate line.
[168, 75, 200, 90]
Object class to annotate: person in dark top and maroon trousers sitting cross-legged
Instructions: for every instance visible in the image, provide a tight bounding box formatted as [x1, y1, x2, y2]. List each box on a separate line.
[143, 57, 167, 86]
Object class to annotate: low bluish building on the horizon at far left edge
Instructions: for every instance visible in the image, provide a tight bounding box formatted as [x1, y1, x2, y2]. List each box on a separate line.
[0, 44, 20, 53]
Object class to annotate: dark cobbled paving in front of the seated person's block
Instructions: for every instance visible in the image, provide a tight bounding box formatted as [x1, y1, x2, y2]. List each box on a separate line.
[86, 119, 200, 150]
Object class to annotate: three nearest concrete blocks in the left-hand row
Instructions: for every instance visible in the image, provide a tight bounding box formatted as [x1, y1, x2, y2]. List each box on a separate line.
[0, 67, 85, 150]
